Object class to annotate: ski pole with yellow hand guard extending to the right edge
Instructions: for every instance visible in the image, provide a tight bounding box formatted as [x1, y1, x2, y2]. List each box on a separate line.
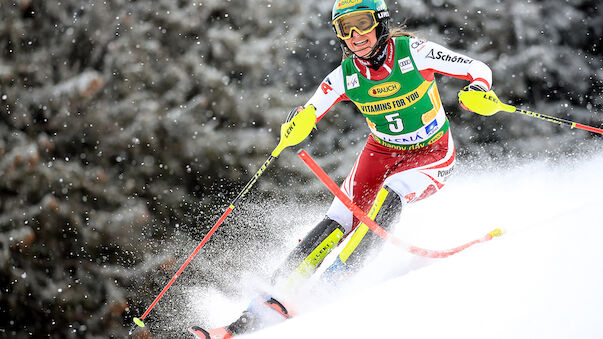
[458, 91, 603, 134]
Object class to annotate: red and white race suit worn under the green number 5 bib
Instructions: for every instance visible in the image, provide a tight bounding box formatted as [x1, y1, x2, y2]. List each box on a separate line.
[305, 38, 492, 235]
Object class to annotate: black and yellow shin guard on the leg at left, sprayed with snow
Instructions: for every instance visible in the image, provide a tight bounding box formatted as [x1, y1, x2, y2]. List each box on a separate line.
[272, 218, 345, 289]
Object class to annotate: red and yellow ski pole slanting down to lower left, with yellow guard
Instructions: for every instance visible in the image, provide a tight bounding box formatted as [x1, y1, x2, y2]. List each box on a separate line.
[130, 109, 316, 334]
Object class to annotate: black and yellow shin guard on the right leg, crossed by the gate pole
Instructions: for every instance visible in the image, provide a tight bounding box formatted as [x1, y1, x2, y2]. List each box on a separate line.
[339, 186, 402, 270]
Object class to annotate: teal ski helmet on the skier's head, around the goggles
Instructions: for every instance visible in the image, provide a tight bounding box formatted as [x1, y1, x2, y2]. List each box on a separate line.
[331, 0, 390, 54]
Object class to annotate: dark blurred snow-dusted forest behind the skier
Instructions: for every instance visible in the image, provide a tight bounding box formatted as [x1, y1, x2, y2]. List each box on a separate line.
[0, 0, 603, 338]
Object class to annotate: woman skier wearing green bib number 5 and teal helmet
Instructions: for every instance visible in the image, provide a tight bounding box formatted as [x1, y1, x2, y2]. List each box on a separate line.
[189, 0, 492, 339]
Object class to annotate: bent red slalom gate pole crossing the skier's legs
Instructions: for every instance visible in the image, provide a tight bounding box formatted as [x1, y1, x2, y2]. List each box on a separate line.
[297, 149, 502, 258]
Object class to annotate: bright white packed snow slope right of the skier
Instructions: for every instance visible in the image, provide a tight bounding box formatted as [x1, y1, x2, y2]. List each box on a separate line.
[241, 144, 603, 339]
